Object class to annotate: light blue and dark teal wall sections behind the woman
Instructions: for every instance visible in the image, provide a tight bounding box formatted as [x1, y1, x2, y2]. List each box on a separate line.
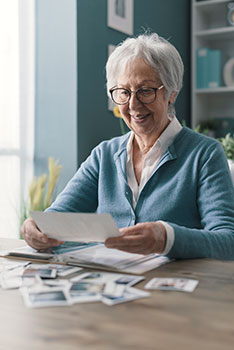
[35, 0, 190, 191]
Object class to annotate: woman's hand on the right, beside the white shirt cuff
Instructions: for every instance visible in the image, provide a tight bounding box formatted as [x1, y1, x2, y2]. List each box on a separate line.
[105, 222, 166, 255]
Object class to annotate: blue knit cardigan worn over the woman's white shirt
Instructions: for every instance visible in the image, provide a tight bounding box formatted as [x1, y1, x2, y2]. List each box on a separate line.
[48, 127, 234, 260]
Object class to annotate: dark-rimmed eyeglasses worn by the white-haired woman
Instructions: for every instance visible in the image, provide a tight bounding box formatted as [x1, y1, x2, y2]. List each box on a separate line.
[109, 85, 164, 105]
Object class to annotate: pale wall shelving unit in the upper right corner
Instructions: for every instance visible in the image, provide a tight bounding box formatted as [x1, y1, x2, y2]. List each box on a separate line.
[191, 0, 234, 131]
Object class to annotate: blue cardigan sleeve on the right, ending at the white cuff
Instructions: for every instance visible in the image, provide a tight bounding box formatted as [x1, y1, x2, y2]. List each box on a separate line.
[168, 143, 234, 260]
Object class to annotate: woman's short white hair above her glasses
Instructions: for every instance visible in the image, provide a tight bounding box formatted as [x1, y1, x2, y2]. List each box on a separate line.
[106, 33, 184, 113]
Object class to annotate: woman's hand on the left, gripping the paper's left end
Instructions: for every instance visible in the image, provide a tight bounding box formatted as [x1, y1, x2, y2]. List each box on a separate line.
[21, 218, 64, 250]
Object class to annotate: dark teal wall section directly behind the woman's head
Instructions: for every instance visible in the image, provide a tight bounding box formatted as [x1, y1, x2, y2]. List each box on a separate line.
[77, 0, 190, 164]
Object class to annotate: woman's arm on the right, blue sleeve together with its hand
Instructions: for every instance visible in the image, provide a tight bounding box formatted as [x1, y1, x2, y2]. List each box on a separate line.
[105, 143, 234, 260]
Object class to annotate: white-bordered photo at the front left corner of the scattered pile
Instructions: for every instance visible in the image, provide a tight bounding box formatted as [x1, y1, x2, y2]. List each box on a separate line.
[21, 287, 70, 307]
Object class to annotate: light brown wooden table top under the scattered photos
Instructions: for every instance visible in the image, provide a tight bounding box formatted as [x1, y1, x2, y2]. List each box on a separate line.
[0, 239, 234, 350]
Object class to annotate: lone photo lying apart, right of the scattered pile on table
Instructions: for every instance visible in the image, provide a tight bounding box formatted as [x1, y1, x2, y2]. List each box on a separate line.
[144, 278, 198, 293]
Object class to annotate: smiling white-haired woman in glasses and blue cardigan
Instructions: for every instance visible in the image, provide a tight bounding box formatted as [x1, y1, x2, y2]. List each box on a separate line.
[22, 33, 234, 259]
